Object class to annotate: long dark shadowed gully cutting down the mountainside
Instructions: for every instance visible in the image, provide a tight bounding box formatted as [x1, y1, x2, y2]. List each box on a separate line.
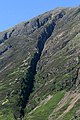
[14, 12, 64, 120]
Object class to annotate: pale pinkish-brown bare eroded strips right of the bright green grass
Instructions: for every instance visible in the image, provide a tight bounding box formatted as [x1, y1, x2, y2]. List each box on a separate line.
[48, 91, 80, 120]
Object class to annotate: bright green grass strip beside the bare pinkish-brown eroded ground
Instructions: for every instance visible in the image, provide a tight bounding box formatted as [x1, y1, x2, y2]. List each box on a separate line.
[25, 92, 64, 120]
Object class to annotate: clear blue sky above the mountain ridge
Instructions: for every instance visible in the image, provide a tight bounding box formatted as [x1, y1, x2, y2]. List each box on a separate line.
[0, 0, 80, 32]
